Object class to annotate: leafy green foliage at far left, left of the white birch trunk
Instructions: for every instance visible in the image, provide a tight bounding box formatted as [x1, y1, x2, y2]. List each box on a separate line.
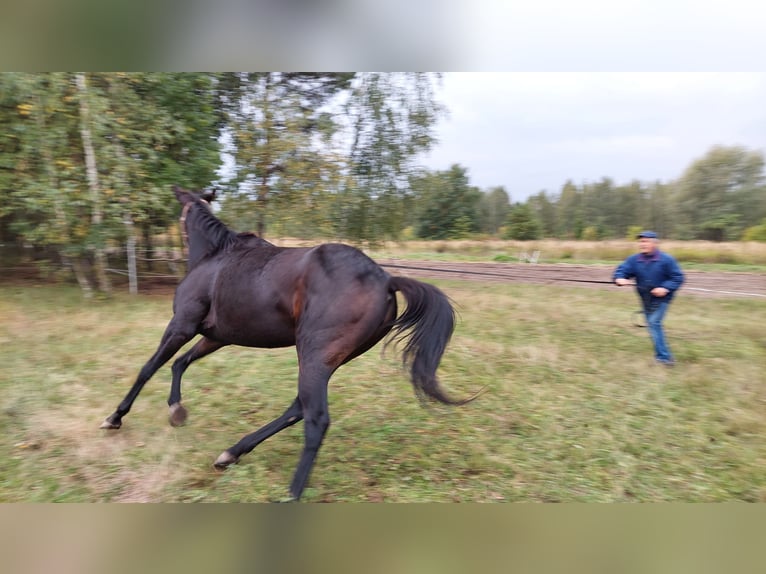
[0, 73, 101, 294]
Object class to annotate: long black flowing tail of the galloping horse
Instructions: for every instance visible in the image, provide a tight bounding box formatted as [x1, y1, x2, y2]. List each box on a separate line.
[389, 277, 476, 405]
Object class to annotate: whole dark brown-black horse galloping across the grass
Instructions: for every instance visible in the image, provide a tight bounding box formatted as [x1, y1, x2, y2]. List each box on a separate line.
[101, 187, 473, 499]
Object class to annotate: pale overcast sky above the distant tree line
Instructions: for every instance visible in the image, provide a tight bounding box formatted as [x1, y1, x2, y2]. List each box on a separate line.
[424, 72, 766, 201]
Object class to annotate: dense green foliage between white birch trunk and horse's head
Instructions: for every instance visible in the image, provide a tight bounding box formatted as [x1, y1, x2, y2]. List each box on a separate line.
[99, 73, 222, 265]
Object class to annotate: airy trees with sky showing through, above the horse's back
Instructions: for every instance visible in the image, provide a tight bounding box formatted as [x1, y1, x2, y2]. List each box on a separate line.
[216, 72, 442, 241]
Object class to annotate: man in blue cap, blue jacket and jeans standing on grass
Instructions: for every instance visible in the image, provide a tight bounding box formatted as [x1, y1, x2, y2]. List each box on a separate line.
[612, 231, 684, 367]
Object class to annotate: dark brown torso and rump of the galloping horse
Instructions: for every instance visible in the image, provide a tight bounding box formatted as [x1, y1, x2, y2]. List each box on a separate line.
[186, 239, 391, 347]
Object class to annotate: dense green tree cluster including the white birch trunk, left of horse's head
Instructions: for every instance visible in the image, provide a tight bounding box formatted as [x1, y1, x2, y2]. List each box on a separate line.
[0, 73, 219, 293]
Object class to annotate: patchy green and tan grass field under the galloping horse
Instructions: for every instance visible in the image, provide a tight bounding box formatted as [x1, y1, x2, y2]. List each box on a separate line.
[0, 282, 766, 502]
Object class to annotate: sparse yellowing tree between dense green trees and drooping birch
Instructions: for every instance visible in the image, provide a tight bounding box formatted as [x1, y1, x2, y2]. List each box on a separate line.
[219, 72, 354, 236]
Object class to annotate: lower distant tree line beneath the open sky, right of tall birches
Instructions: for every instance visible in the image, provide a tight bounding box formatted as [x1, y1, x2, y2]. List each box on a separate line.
[410, 146, 766, 241]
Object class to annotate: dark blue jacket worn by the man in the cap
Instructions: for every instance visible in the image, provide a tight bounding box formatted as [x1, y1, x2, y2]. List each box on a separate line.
[612, 251, 684, 304]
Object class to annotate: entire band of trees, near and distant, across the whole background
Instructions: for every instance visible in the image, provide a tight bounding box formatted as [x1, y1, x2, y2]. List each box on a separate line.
[0, 72, 766, 293]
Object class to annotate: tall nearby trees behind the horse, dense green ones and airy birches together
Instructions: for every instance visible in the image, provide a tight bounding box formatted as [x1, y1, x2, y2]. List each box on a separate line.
[0, 72, 443, 293]
